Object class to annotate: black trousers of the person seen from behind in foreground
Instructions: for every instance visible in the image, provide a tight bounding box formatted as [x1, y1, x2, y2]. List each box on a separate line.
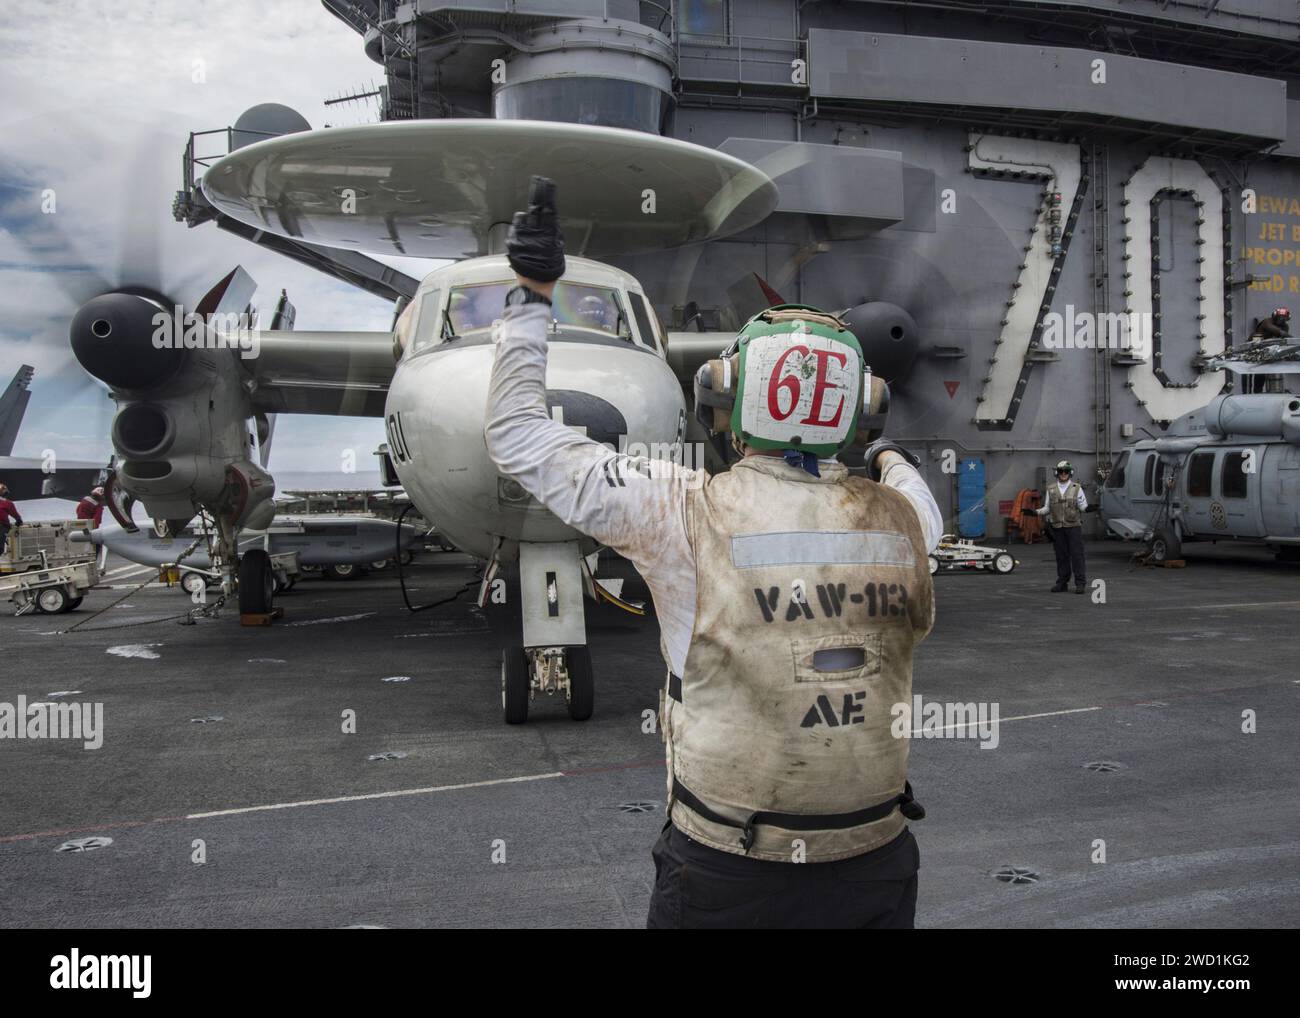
[646, 823, 920, 930]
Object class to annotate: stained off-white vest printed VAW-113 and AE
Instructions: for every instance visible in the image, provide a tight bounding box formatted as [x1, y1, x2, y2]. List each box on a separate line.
[662, 456, 935, 862]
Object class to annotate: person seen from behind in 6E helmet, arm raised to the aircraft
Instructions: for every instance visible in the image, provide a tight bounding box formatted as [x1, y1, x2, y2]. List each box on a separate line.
[486, 182, 943, 927]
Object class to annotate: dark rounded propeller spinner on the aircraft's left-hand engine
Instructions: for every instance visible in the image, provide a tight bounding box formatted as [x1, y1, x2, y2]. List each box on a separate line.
[68, 294, 185, 389]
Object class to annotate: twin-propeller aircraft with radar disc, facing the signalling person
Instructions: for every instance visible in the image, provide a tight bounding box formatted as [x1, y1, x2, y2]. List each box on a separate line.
[70, 119, 898, 719]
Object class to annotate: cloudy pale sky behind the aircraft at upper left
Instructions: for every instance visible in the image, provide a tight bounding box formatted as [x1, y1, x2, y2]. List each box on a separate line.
[0, 0, 437, 472]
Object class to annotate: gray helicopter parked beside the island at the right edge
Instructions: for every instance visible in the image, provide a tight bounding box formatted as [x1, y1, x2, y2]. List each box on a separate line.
[1101, 339, 1300, 562]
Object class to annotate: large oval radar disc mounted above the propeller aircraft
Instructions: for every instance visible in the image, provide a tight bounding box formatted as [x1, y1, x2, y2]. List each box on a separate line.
[203, 120, 777, 257]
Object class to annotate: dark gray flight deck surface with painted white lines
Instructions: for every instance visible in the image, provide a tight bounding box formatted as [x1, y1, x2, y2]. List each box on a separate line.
[0, 542, 1300, 928]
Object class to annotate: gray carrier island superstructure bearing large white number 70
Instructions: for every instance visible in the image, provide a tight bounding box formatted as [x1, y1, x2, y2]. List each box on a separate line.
[180, 0, 1300, 536]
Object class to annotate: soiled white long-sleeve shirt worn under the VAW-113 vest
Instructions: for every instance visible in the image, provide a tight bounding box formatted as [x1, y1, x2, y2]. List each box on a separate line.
[485, 304, 944, 675]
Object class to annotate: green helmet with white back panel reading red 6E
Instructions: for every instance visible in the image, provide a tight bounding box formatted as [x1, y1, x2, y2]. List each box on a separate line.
[731, 304, 863, 458]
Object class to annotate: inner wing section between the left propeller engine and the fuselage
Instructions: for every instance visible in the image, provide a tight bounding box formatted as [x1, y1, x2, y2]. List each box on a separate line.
[244, 330, 397, 417]
